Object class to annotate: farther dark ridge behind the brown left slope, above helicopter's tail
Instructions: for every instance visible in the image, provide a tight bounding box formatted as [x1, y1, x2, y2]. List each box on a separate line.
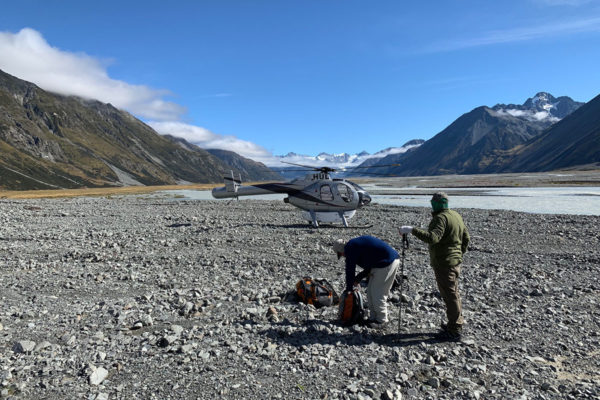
[163, 135, 281, 182]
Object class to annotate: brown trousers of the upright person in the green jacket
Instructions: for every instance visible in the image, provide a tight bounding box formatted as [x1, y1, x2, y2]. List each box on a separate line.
[433, 264, 464, 333]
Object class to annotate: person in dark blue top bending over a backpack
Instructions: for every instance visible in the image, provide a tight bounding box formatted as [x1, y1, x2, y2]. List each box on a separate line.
[333, 236, 400, 328]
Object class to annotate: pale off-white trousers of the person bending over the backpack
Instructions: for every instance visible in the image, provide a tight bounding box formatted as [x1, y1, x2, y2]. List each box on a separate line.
[367, 259, 400, 322]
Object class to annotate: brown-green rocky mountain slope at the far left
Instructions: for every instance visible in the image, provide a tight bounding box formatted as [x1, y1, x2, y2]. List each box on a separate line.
[0, 71, 244, 190]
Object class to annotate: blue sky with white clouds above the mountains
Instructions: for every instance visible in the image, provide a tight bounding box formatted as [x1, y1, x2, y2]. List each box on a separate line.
[0, 0, 600, 165]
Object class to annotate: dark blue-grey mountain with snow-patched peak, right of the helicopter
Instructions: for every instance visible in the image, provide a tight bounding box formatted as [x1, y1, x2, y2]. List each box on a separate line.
[367, 92, 583, 176]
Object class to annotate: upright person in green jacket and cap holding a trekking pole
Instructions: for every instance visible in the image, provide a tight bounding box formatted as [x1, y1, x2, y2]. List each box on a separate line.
[400, 192, 470, 340]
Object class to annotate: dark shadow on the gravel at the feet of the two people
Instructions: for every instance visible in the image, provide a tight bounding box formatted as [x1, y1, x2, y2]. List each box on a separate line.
[259, 320, 443, 347]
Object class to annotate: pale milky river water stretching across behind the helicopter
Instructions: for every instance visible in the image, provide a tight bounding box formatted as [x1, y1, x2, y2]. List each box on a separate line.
[163, 185, 600, 215]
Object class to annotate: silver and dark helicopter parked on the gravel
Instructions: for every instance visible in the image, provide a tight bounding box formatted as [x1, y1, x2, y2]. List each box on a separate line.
[212, 162, 396, 228]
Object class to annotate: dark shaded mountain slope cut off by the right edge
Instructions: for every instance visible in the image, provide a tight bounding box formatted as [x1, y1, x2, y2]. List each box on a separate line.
[498, 95, 600, 172]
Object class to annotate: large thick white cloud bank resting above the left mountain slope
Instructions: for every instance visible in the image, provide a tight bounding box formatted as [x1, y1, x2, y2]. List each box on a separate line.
[0, 28, 186, 120]
